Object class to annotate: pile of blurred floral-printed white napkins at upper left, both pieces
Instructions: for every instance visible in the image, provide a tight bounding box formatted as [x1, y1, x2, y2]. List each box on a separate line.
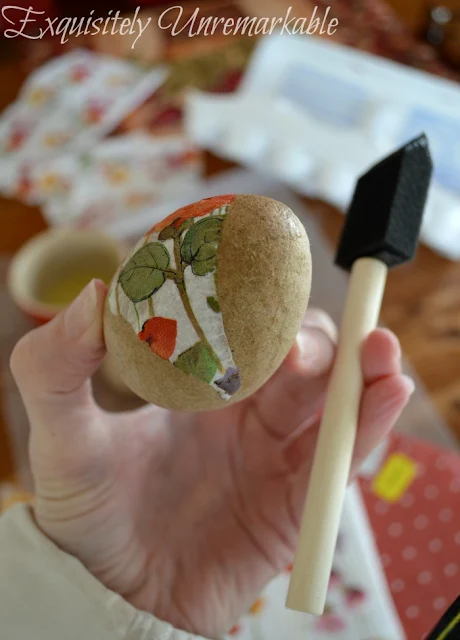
[0, 50, 201, 228]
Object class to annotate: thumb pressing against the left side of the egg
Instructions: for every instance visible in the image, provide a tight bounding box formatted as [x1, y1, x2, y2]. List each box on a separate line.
[11, 280, 107, 426]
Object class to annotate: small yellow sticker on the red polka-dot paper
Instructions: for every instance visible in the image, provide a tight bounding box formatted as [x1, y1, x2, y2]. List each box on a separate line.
[372, 453, 417, 502]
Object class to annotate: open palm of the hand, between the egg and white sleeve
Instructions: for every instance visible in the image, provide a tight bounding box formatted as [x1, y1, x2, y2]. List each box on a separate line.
[33, 352, 325, 637]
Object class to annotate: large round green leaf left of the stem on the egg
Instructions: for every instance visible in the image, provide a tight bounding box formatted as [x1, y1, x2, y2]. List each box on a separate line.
[118, 242, 170, 302]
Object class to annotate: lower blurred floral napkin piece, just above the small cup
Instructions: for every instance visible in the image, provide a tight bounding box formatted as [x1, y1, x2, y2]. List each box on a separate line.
[30, 131, 202, 229]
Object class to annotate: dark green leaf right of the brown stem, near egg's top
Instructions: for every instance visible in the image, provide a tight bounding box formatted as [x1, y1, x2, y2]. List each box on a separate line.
[181, 216, 225, 276]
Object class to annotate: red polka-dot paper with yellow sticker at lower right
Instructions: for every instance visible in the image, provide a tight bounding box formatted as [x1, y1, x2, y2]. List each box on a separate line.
[360, 435, 460, 640]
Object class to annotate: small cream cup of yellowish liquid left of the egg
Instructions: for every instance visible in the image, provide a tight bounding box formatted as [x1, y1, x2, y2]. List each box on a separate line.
[8, 229, 125, 324]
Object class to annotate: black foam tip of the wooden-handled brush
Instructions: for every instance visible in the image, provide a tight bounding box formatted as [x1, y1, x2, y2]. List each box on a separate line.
[336, 134, 433, 270]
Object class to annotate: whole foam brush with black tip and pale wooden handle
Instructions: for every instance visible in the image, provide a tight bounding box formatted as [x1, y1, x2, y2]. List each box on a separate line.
[286, 135, 433, 615]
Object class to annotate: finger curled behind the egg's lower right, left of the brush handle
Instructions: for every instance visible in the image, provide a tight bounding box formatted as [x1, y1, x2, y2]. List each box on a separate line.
[252, 309, 336, 438]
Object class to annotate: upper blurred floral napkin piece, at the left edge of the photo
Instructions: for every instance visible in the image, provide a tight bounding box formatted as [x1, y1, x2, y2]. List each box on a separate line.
[0, 49, 165, 204]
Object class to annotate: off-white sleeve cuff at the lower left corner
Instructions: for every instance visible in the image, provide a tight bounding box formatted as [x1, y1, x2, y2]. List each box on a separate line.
[0, 505, 212, 640]
